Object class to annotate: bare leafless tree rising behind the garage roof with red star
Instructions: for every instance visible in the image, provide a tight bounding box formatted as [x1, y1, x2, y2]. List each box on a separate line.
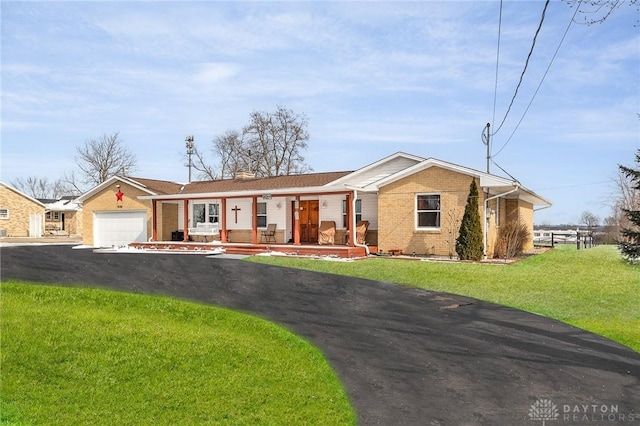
[63, 132, 137, 192]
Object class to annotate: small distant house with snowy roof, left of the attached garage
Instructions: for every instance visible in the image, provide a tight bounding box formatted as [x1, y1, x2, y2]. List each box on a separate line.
[38, 196, 82, 235]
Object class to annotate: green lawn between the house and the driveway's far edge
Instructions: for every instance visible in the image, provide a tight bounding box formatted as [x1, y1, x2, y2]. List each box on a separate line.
[250, 246, 640, 352]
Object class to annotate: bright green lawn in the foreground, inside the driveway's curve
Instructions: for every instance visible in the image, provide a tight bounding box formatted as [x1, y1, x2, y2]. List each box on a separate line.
[0, 281, 355, 425]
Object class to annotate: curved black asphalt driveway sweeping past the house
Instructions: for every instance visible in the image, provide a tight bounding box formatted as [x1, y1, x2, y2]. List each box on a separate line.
[0, 246, 640, 426]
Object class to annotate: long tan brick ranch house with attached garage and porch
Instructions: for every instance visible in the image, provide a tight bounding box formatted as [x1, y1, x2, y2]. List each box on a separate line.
[79, 153, 551, 256]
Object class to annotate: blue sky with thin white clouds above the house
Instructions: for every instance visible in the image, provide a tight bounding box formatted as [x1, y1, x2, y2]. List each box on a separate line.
[0, 0, 640, 225]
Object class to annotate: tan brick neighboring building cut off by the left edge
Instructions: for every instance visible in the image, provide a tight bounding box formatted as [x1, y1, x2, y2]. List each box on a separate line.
[0, 182, 46, 238]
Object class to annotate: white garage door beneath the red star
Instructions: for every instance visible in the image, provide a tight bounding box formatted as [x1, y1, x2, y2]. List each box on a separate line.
[93, 211, 147, 247]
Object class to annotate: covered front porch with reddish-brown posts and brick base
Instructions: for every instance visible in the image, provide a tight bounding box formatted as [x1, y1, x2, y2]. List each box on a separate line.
[144, 187, 375, 253]
